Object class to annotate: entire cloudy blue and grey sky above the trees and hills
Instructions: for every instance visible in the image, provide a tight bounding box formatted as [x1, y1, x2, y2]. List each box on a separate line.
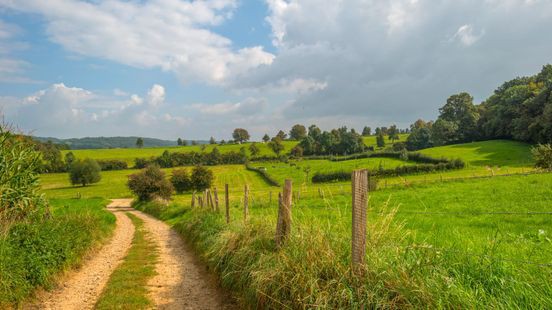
[0, 0, 552, 139]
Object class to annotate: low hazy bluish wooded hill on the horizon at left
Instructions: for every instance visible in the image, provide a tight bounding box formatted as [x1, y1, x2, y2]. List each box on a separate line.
[33, 137, 208, 150]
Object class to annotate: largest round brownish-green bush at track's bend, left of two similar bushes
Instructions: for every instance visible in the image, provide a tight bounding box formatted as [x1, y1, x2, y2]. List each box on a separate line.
[128, 164, 174, 201]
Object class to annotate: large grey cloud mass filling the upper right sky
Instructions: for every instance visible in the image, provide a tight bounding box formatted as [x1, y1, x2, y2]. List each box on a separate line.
[233, 0, 552, 127]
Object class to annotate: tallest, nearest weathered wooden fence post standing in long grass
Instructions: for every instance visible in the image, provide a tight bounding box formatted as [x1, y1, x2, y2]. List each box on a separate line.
[352, 170, 368, 274]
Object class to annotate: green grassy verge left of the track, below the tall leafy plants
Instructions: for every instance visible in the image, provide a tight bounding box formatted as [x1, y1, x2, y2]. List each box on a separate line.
[0, 199, 115, 308]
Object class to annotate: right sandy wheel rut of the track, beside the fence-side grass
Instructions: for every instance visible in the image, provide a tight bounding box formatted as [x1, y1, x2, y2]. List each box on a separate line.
[132, 205, 237, 309]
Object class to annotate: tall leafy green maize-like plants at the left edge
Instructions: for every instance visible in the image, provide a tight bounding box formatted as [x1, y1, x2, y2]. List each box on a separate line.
[0, 126, 47, 224]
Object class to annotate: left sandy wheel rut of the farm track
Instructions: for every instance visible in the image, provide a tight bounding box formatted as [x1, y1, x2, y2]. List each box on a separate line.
[32, 200, 134, 310]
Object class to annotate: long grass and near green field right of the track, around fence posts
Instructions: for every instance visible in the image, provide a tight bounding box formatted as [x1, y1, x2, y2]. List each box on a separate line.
[137, 175, 552, 309]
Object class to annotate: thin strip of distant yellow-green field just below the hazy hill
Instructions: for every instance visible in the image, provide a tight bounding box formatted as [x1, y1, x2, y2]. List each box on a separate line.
[62, 141, 297, 166]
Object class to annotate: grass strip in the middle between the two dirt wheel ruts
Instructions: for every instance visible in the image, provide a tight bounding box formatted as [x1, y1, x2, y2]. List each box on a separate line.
[96, 213, 158, 309]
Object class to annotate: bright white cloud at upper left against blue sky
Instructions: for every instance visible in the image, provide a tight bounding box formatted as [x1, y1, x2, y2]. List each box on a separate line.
[0, 0, 274, 84]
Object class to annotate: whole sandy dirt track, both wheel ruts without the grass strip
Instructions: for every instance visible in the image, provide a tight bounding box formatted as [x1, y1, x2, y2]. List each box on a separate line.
[29, 199, 236, 310]
